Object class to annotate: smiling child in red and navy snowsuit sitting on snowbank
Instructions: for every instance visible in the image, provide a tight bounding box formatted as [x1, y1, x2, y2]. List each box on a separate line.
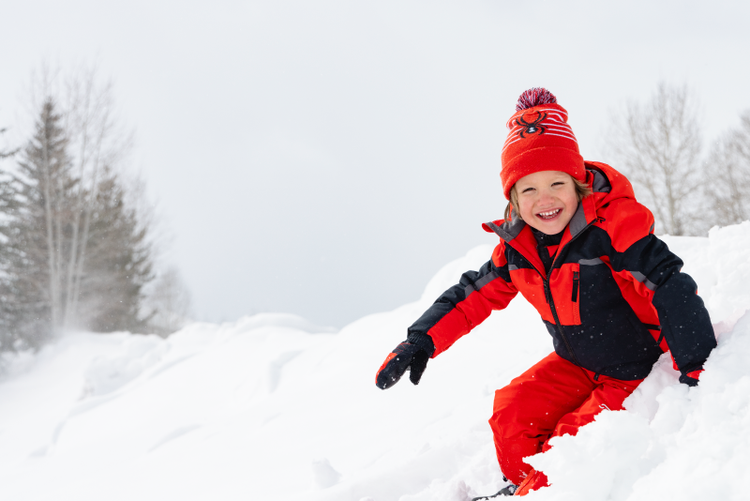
[377, 88, 716, 499]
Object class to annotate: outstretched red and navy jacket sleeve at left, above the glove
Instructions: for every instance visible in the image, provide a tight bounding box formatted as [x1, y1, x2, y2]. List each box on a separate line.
[407, 243, 518, 357]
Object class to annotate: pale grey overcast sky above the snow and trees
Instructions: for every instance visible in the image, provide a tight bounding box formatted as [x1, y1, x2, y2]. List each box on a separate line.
[0, 0, 750, 327]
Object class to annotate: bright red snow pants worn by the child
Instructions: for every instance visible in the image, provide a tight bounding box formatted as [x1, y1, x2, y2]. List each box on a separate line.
[490, 353, 643, 496]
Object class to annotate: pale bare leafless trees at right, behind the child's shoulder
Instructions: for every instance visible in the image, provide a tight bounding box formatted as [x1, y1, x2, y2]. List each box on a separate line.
[605, 82, 750, 235]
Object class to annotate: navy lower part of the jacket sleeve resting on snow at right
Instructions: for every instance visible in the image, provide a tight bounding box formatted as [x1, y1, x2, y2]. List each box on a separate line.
[610, 209, 716, 384]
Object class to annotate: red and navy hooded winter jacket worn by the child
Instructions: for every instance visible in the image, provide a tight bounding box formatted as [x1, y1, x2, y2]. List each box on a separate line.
[408, 162, 716, 380]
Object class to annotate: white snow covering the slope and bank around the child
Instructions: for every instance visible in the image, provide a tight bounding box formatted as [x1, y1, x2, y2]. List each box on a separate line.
[0, 222, 750, 501]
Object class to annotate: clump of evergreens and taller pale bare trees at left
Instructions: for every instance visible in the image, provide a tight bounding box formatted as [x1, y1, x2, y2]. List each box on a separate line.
[0, 70, 186, 351]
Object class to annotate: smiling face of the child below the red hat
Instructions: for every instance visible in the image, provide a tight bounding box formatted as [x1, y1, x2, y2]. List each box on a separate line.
[514, 170, 578, 235]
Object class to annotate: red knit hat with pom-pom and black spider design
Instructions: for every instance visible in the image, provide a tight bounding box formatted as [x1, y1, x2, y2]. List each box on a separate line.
[500, 87, 586, 200]
